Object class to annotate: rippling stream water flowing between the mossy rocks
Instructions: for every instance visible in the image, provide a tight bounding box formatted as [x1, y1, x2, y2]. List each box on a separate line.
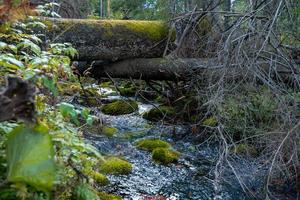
[78, 84, 263, 200]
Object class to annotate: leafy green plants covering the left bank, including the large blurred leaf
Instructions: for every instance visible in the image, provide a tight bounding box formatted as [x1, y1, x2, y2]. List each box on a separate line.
[0, 4, 105, 199]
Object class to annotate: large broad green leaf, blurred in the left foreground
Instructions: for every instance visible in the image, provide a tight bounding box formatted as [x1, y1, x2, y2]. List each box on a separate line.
[7, 125, 55, 192]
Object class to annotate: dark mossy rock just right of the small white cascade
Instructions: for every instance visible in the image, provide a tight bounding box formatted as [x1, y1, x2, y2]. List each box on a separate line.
[143, 106, 176, 121]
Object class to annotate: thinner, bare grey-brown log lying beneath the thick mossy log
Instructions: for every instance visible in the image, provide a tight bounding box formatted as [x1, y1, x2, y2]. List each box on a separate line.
[88, 58, 299, 83]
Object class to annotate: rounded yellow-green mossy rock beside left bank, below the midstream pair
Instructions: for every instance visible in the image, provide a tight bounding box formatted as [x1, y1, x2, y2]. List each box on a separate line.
[100, 157, 132, 175]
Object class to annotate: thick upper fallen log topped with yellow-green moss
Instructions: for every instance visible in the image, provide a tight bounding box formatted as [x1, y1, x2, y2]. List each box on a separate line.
[42, 18, 175, 61]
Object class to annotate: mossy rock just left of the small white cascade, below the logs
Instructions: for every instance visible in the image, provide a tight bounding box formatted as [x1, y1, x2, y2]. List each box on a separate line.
[101, 100, 138, 115]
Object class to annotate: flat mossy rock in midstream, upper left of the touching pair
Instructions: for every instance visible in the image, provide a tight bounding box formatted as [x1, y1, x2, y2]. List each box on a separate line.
[136, 139, 171, 152]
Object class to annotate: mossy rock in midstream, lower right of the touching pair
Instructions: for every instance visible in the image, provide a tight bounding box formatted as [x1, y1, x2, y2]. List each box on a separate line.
[152, 148, 180, 165]
